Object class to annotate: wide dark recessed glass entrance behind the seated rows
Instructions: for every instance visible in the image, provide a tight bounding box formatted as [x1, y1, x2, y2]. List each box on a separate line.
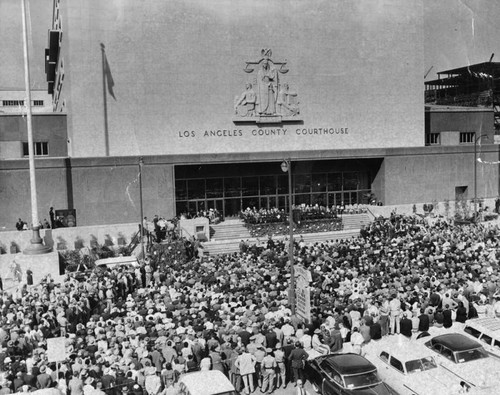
[175, 159, 381, 218]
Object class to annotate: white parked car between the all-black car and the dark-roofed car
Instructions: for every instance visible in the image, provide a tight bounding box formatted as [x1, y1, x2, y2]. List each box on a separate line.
[364, 335, 467, 395]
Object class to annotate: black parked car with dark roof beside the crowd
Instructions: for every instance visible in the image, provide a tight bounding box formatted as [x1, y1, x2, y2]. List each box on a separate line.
[305, 353, 397, 395]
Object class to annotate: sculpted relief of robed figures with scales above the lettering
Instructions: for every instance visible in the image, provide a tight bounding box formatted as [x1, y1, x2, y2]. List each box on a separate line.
[234, 49, 301, 123]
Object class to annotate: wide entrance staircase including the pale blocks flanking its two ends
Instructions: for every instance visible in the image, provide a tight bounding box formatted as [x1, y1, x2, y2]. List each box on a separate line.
[203, 214, 371, 255]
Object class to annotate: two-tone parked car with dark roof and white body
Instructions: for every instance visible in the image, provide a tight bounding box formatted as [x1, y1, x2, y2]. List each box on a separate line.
[421, 333, 500, 393]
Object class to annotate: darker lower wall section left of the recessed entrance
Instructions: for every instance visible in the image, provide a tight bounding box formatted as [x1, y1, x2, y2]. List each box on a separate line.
[0, 158, 175, 229]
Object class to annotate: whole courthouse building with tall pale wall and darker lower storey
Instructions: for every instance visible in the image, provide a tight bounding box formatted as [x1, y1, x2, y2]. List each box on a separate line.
[0, 0, 499, 225]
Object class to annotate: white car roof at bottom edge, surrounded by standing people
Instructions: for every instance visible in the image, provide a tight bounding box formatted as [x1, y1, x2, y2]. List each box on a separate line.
[179, 370, 234, 395]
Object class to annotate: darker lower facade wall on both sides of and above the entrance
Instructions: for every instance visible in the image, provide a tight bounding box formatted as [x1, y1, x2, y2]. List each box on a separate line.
[0, 145, 499, 229]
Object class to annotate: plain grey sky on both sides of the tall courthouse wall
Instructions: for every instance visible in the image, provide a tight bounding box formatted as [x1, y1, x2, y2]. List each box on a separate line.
[0, 0, 500, 90]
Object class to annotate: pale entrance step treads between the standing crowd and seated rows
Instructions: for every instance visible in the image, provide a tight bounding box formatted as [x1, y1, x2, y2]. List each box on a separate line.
[203, 228, 359, 255]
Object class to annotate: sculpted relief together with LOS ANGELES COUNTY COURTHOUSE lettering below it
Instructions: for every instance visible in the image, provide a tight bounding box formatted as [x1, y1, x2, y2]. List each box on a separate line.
[178, 49, 349, 138]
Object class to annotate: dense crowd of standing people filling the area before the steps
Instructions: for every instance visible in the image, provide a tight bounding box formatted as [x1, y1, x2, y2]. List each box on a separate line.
[0, 214, 500, 395]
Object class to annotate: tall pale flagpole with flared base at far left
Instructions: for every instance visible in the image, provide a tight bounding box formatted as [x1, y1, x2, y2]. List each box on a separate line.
[22, 0, 51, 255]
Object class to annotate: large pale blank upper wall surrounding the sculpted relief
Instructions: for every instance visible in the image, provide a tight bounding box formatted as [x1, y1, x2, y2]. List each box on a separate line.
[60, 0, 424, 157]
